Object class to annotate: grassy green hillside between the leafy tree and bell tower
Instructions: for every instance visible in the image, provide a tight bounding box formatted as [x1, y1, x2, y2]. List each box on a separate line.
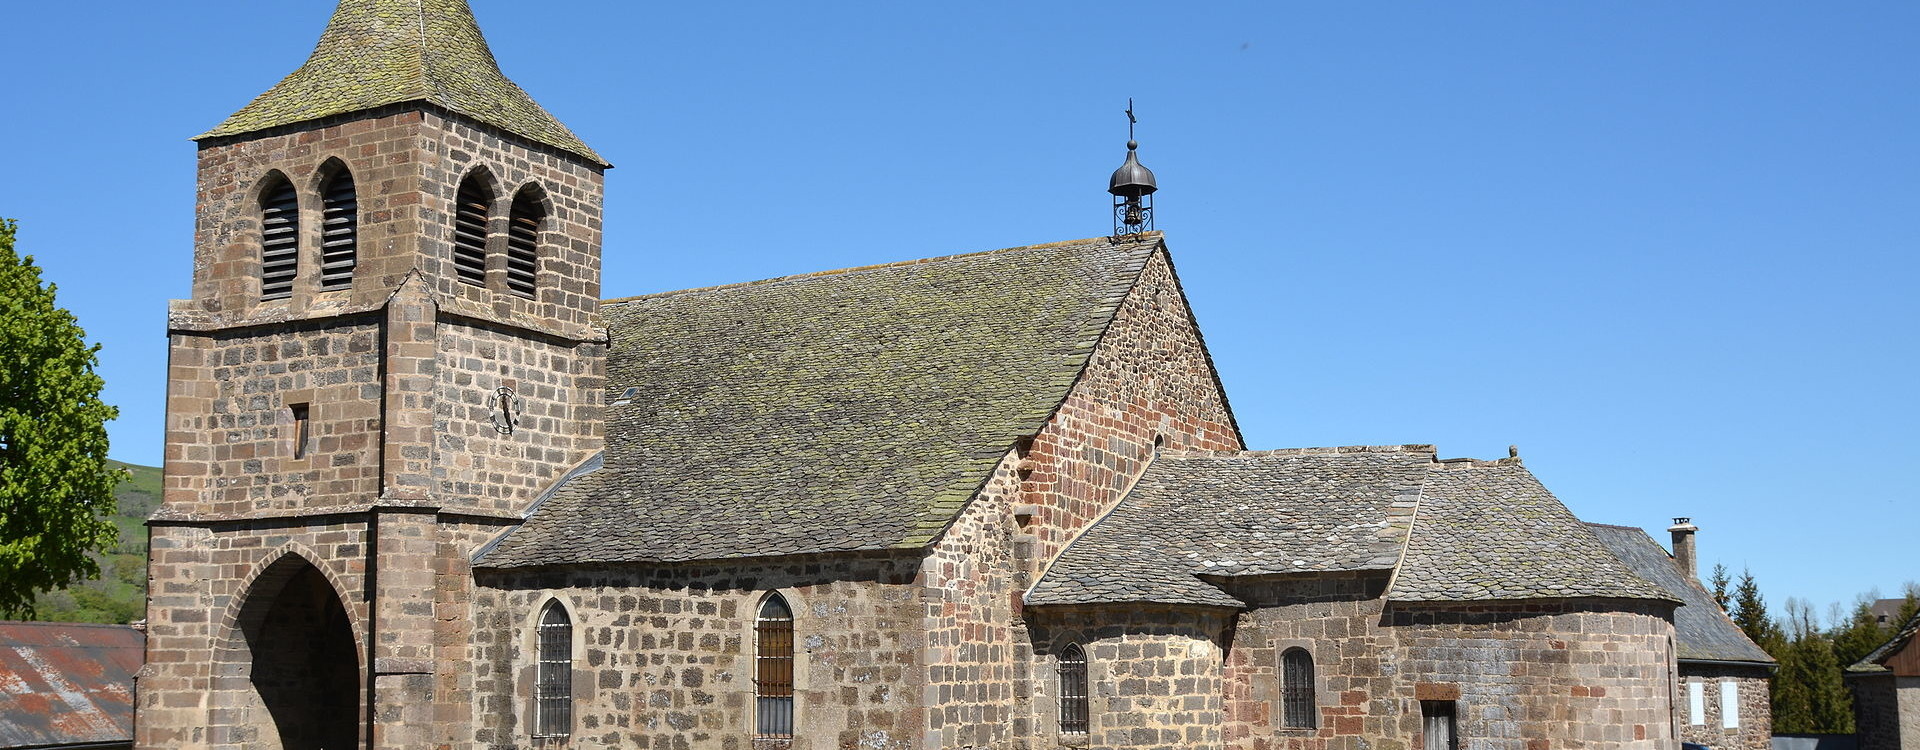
[35, 460, 159, 623]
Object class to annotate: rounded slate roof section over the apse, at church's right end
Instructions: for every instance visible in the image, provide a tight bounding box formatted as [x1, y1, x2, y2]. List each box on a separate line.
[1386, 458, 1676, 602]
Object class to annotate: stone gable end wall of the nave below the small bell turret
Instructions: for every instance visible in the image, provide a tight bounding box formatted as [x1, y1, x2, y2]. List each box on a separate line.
[920, 249, 1242, 748]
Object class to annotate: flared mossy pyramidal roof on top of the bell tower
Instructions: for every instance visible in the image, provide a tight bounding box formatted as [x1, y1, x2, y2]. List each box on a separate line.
[194, 0, 607, 167]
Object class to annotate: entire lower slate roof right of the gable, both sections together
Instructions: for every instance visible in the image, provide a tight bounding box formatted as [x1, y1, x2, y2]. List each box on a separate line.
[1027, 445, 1676, 606]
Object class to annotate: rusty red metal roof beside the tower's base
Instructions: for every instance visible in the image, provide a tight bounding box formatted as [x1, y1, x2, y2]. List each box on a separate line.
[0, 621, 146, 748]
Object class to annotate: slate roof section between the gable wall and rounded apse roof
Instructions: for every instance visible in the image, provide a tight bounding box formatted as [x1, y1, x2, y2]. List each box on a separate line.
[1027, 445, 1432, 608]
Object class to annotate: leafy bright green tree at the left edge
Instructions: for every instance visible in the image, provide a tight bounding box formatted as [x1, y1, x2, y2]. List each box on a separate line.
[0, 219, 121, 618]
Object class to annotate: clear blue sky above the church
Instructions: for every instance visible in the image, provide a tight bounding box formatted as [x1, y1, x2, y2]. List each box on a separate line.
[0, 0, 1920, 612]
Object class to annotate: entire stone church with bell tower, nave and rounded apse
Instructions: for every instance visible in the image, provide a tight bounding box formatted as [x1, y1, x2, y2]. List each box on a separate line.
[134, 0, 1720, 750]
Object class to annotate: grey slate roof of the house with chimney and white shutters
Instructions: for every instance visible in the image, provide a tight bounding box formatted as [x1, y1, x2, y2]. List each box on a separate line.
[1588, 524, 1774, 664]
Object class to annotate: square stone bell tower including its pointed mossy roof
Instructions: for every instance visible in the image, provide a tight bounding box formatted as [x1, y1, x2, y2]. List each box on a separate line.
[134, 0, 611, 750]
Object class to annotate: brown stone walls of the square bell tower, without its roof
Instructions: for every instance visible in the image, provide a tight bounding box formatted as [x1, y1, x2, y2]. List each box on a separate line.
[136, 77, 605, 748]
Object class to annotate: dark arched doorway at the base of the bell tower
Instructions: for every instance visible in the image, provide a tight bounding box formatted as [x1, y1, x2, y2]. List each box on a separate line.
[221, 554, 363, 750]
